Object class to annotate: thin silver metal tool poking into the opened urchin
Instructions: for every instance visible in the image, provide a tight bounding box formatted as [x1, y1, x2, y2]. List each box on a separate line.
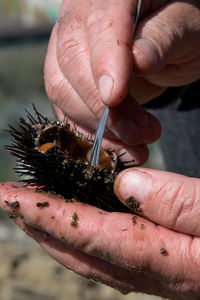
[90, 0, 142, 166]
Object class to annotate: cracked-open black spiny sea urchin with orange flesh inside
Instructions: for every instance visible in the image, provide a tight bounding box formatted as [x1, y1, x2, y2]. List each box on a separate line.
[6, 105, 134, 212]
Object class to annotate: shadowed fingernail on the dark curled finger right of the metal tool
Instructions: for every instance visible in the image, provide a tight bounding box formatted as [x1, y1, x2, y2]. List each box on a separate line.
[114, 119, 140, 145]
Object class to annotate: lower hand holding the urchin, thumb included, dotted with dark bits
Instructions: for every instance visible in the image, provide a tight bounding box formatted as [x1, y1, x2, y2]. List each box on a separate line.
[0, 168, 200, 300]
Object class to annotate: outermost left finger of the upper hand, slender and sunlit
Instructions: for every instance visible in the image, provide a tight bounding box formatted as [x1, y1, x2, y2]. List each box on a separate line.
[44, 25, 98, 128]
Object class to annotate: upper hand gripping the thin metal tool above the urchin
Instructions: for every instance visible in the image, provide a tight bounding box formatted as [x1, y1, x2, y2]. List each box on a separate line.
[44, 0, 200, 145]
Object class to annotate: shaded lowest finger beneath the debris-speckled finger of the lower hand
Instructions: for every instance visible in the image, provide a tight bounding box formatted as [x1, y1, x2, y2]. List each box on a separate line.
[20, 224, 166, 295]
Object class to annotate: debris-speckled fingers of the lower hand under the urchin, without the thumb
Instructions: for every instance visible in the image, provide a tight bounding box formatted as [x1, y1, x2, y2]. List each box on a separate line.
[0, 178, 200, 299]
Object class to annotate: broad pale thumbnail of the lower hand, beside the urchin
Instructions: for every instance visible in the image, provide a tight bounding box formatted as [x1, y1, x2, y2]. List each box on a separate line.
[115, 170, 152, 204]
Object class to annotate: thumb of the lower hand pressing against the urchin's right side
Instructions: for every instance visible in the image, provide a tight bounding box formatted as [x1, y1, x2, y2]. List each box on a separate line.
[114, 168, 200, 236]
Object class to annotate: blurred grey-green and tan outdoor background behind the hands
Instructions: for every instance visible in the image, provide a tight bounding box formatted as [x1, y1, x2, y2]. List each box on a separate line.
[0, 0, 165, 300]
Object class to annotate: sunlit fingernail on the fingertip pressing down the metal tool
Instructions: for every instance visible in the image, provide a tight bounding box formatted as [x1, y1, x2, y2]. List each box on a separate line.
[98, 75, 114, 104]
